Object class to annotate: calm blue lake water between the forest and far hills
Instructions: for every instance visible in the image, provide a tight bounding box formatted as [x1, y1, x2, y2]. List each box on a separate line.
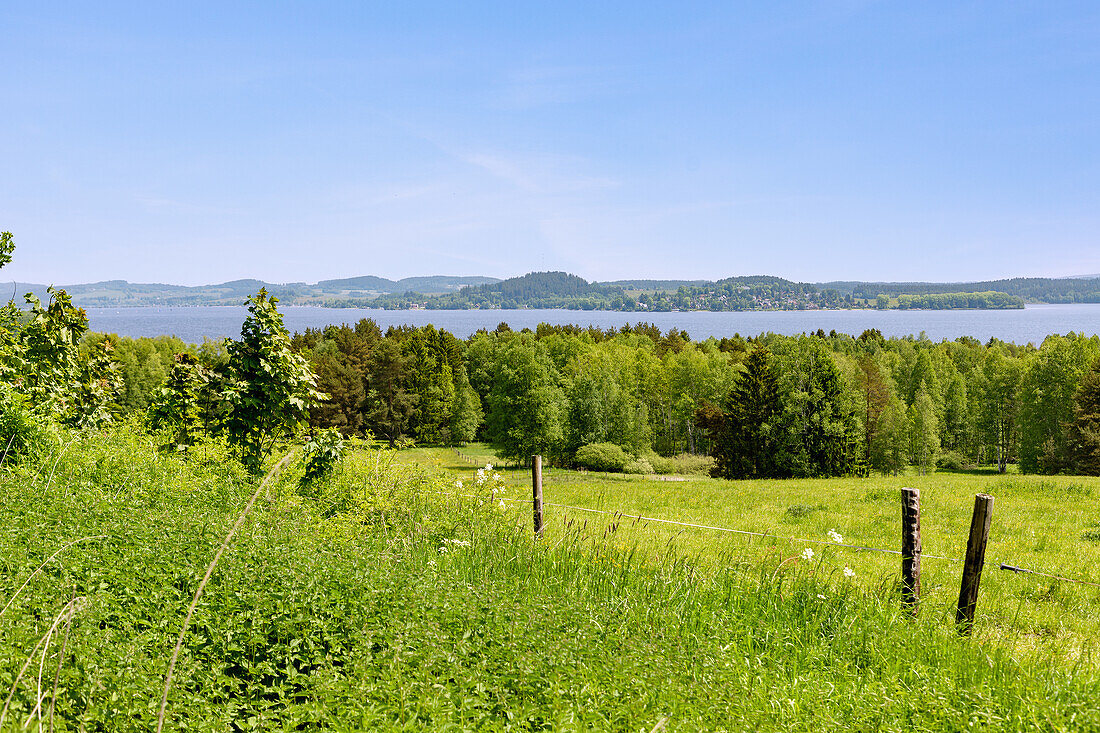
[87, 304, 1100, 346]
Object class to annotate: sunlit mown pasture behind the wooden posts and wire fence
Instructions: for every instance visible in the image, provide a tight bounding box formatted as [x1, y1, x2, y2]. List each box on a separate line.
[404, 445, 1100, 659]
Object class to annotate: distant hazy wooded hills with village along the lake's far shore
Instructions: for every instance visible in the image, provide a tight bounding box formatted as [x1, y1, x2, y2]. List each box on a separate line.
[15, 272, 1100, 311]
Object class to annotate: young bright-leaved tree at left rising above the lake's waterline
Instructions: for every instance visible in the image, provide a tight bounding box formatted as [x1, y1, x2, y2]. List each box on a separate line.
[223, 288, 325, 473]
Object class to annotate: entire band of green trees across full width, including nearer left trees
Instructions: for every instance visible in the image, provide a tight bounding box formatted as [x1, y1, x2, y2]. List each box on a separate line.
[0, 220, 1100, 478]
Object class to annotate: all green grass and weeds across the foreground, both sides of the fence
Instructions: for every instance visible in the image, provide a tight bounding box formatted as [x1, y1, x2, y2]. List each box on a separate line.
[0, 428, 1100, 733]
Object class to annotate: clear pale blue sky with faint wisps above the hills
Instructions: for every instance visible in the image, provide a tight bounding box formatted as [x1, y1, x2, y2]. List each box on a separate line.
[0, 0, 1100, 284]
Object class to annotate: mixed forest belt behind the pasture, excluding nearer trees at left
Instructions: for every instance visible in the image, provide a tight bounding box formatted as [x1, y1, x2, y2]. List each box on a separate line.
[268, 320, 1100, 478]
